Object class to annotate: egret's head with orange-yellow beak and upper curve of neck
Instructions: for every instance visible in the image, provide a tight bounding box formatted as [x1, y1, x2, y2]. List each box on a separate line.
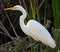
[4, 5, 27, 17]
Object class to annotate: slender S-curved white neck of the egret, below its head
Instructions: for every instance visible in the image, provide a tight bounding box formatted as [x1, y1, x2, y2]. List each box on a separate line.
[20, 8, 27, 31]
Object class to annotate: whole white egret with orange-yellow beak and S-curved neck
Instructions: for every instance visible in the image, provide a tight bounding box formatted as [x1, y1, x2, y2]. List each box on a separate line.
[4, 5, 56, 48]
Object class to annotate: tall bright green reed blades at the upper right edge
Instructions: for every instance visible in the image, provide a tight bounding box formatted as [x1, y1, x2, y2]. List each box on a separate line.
[52, 0, 60, 29]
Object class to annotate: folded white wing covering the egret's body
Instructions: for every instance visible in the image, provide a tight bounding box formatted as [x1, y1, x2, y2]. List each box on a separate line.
[27, 20, 54, 45]
